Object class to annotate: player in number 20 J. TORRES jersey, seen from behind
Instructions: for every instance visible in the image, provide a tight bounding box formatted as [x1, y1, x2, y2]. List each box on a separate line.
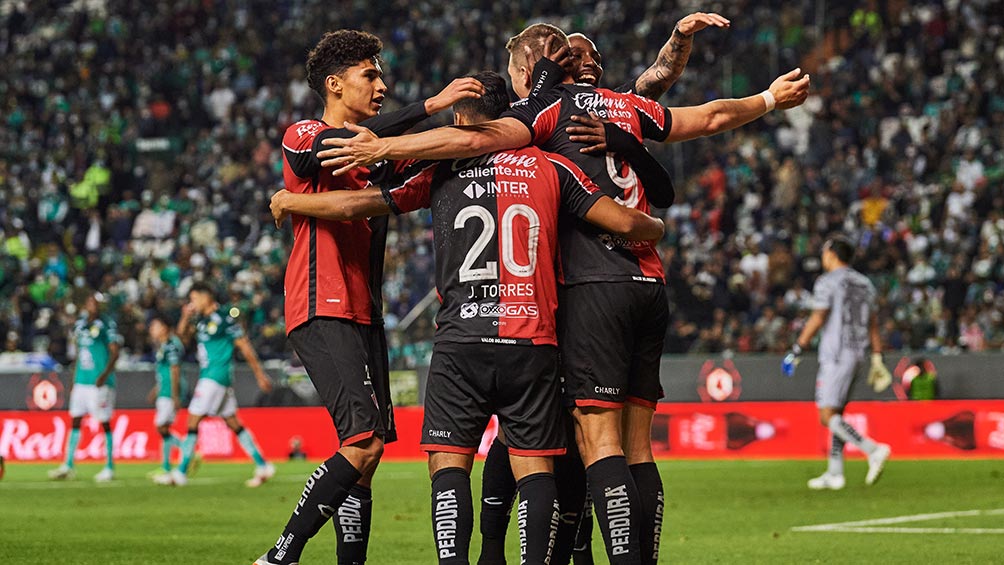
[272, 72, 665, 564]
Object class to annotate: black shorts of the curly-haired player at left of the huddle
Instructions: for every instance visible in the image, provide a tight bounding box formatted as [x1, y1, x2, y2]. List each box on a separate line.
[289, 317, 398, 445]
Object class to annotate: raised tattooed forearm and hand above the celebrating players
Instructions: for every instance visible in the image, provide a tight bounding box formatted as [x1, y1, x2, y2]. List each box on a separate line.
[635, 12, 730, 100]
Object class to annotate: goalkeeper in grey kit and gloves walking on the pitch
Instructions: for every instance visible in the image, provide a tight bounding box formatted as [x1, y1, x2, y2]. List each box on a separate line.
[781, 236, 892, 491]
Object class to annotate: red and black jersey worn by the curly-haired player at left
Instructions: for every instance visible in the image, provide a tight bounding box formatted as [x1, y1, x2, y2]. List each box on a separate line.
[282, 100, 429, 332]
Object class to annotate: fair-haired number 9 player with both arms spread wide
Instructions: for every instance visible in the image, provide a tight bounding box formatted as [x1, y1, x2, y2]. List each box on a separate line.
[318, 24, 809, 563]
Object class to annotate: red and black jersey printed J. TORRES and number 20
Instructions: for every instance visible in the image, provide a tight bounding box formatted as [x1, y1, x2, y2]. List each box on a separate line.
[384, 148, 602, 345]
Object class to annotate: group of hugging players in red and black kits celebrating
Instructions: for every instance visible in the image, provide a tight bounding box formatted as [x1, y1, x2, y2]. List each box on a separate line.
[256, 13, 809, 565]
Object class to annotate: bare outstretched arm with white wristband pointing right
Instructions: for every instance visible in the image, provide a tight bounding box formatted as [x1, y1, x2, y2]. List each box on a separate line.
[665, 68, 809, 143]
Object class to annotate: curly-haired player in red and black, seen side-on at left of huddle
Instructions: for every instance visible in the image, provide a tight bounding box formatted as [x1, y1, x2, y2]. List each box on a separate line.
[256, 30, 481, 565]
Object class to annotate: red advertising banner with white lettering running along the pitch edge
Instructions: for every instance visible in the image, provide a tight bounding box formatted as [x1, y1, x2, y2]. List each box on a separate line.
[0, 400, 1004, 462]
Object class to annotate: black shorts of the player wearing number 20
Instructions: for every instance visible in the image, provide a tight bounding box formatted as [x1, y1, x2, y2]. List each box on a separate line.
[421, 342, 565, 457]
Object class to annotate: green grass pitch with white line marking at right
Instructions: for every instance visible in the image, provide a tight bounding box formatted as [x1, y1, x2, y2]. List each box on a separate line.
[0, 460, 1004, 565]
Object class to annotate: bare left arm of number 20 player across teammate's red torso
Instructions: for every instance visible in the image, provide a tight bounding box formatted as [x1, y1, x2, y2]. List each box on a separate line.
[269, 187, 391, 227]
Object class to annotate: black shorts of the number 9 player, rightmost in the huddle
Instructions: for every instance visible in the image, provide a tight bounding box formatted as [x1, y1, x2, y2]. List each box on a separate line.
[557, 282, 670, 408]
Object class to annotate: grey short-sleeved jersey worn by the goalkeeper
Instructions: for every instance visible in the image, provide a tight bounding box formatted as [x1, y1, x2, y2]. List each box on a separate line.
[812, 267, 875, 359]
